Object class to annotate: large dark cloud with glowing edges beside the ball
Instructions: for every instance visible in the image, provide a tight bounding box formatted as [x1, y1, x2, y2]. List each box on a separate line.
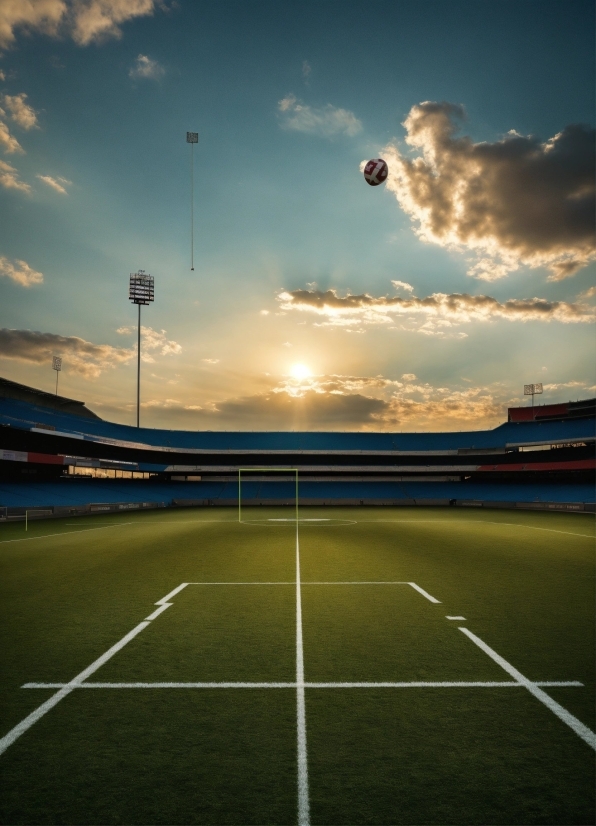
[382, 101, 596, 281]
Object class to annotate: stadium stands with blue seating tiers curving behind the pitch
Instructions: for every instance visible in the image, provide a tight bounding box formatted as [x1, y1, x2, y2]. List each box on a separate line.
[0, 380, 596, 514]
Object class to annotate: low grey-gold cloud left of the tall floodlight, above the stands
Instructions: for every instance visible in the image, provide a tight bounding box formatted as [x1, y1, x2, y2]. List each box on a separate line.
[0, 329, 135, 378]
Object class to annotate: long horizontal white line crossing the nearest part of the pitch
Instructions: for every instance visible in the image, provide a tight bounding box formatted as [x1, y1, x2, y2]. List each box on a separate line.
[21, 680, 583, 689]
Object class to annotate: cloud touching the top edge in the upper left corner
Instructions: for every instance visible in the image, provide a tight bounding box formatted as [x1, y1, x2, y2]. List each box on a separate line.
[0, 0, 163, 48]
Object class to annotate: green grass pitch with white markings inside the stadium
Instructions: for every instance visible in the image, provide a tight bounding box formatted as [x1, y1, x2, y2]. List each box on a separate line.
[0, 508, 595, 826]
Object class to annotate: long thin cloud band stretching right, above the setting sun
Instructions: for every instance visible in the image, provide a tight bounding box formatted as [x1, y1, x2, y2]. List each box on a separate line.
[277, 290, 596, 338]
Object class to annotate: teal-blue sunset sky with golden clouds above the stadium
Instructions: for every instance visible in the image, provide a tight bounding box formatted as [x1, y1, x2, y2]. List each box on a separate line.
[0, 0, 596, 430]
